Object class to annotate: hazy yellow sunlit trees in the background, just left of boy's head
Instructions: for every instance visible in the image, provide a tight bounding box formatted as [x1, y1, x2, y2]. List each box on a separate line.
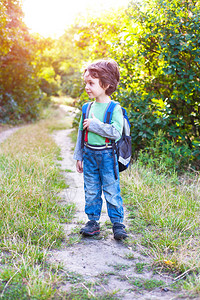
[40, 24, 85, 98]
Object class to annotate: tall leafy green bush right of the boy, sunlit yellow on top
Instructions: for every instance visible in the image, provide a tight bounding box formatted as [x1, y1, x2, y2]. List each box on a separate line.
[114, 0, 200, 169]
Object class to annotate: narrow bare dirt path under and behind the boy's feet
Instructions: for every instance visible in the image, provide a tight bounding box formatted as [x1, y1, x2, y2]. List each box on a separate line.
[51, 130, 180, 300]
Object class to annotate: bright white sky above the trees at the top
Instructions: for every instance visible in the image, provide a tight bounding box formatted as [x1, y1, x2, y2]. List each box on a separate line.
[22, 0, 130, 37]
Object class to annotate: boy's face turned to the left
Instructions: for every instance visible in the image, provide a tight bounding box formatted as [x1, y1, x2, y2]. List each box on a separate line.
[84, 71, 107, 100]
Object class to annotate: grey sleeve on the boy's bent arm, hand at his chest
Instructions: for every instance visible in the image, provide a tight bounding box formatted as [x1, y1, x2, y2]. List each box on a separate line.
[89, 105, 123, 140]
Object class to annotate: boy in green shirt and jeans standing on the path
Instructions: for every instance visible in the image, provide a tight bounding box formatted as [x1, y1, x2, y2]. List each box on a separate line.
[74, 60, 128, 240]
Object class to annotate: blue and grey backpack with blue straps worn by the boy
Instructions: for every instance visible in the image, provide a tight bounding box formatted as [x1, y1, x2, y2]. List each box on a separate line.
[82, 100, 132, 178]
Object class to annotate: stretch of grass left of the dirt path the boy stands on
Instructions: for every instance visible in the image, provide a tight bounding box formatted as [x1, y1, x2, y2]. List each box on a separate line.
[0, 104, 75, 299]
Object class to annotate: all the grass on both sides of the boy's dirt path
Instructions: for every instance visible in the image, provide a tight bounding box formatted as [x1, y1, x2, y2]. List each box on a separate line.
[0, 104, 200, 300]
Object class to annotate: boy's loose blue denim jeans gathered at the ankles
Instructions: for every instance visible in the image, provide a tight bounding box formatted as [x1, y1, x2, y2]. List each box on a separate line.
[83, 146, 124, 223]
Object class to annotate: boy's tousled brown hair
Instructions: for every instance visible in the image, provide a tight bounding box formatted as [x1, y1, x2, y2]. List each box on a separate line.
[84, 59, 120, 96]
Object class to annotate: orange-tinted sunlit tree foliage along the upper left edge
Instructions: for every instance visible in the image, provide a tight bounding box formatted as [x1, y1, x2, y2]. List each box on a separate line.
[0, 0, 45, 122]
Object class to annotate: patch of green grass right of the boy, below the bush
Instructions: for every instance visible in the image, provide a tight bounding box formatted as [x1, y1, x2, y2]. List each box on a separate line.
[121, 164, 200, 290]
